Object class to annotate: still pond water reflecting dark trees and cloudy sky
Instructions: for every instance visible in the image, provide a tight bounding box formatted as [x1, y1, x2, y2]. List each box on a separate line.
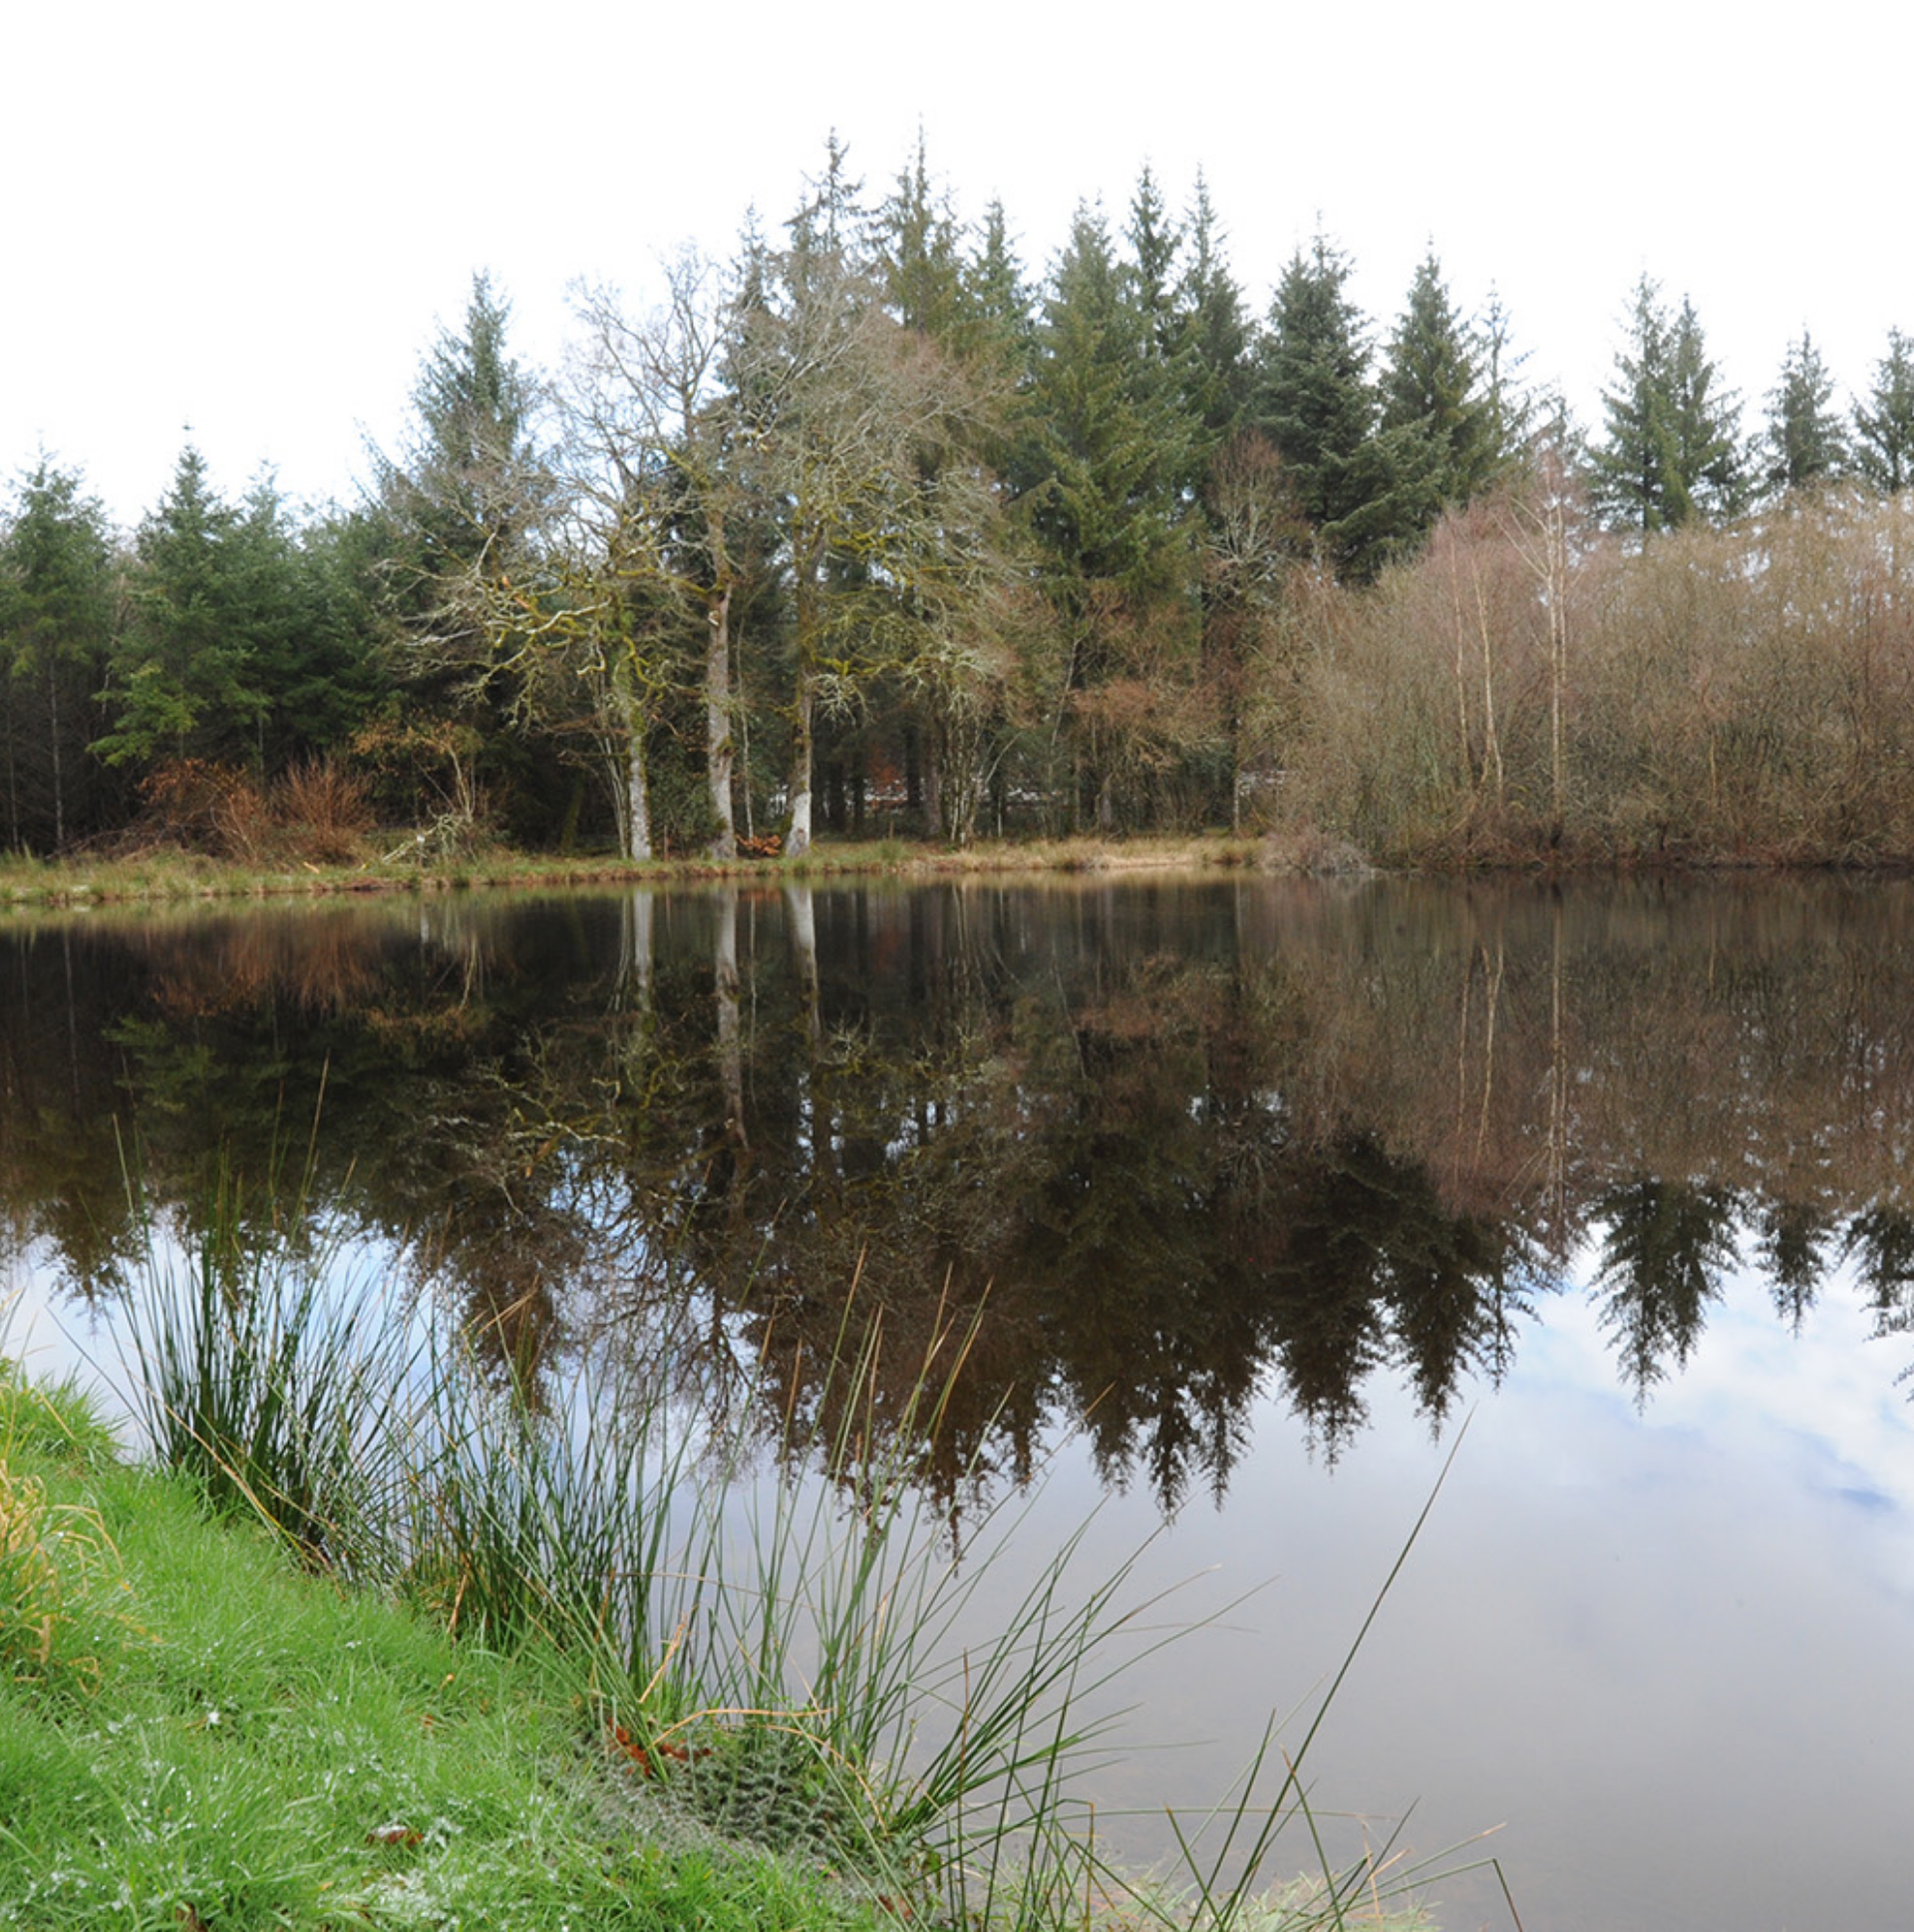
[0, 879, 1914, 1932]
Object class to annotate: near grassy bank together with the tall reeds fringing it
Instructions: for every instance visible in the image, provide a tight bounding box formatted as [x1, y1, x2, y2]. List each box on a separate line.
[0, 1197, 1482, 1932]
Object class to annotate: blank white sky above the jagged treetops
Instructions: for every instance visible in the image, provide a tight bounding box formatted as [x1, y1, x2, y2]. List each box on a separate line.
[0, 0, 1914, 523]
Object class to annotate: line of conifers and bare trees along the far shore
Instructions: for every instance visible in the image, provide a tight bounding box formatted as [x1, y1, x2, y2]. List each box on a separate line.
[0, 141, 1914, 863]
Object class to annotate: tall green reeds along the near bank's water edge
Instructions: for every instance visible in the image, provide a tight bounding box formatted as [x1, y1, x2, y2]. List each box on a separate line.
[108, 1196, 1513, 1932]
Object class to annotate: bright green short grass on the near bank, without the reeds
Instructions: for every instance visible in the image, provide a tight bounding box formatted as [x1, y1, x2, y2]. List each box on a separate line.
[0, 1382, 892, 1932]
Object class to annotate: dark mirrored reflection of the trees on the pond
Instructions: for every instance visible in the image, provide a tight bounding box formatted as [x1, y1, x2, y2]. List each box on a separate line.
[11, 881, 1914, 1507]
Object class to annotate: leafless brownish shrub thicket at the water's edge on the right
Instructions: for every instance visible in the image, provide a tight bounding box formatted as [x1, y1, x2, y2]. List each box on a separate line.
[1284, 492, 1914, 863]
